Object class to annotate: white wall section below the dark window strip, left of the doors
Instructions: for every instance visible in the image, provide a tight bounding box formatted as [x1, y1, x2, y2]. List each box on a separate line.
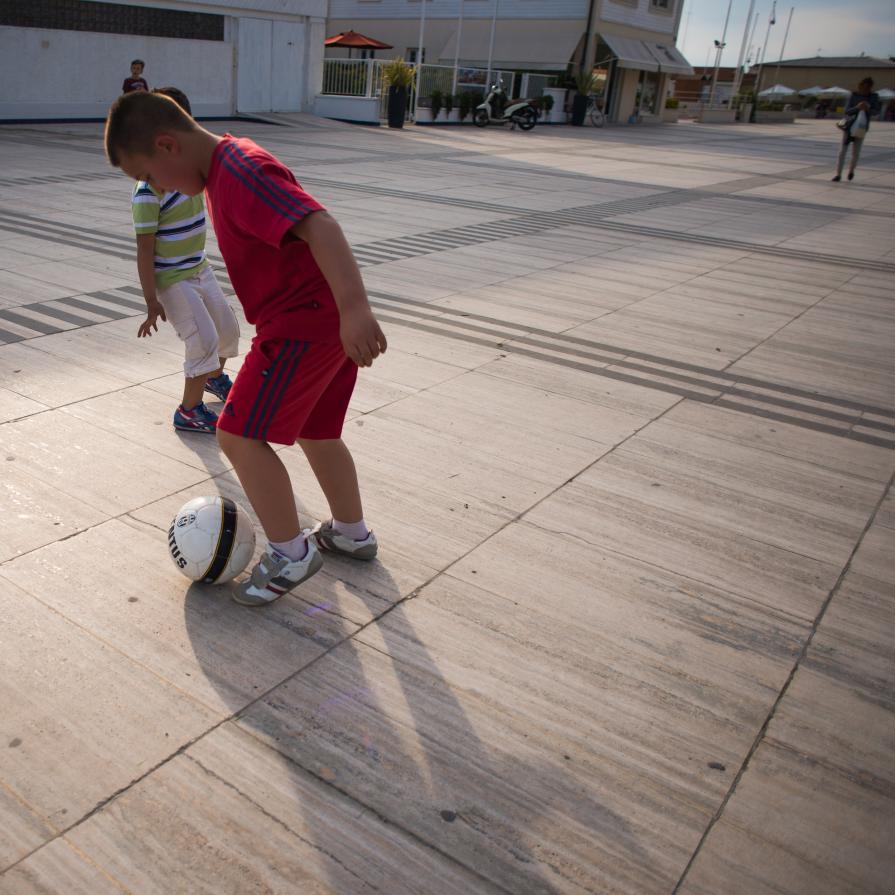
[0, 27, 233, 118]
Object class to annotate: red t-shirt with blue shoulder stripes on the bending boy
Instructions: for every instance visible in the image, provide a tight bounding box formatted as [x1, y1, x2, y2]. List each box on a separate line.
[205, 134, 339, 342]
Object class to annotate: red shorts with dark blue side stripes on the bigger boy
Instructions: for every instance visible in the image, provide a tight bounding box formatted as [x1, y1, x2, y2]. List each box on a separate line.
[218, 336, 357, 444]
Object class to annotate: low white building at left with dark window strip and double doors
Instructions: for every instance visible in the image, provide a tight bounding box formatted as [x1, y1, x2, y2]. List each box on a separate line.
[0, 0, 327, 120]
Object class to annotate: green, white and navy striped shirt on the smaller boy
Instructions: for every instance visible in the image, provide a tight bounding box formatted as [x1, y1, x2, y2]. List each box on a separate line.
[132, 180, 208, 289]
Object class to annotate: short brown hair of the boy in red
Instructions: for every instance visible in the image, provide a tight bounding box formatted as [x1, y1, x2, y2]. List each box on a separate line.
[105, 91, 196, 168]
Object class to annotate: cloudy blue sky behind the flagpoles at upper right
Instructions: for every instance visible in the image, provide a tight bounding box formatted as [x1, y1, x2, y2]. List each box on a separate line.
[677, 0, 895, 71]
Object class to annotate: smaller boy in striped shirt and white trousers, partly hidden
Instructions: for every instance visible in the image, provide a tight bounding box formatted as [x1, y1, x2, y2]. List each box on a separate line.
[132, 87, 239, 433]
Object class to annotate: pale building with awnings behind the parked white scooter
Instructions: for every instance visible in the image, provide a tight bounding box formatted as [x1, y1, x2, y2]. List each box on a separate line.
[327, 0, 692, 121]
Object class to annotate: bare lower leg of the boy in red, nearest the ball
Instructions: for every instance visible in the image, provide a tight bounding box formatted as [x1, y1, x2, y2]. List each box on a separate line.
[218, 429, 301, 543]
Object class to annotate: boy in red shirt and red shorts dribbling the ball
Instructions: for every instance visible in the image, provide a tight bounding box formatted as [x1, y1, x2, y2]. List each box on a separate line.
[105, 92, 386, 606]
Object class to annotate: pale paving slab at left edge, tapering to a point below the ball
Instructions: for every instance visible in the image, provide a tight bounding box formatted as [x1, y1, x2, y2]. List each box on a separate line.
[0, 568, 214, 860]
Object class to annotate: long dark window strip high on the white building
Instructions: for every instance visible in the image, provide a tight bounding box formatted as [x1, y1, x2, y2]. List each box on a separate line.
[0, 0, 224, 40]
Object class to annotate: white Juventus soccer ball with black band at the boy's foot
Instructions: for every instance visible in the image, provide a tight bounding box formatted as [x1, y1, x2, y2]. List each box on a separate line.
[168, 496, 255, 584]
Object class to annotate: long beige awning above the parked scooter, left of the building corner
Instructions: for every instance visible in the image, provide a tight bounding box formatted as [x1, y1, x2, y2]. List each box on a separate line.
[439, 19, 582, 71]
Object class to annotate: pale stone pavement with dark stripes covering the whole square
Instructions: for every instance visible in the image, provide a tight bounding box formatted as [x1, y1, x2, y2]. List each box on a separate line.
[0, 116, 895, 895]
